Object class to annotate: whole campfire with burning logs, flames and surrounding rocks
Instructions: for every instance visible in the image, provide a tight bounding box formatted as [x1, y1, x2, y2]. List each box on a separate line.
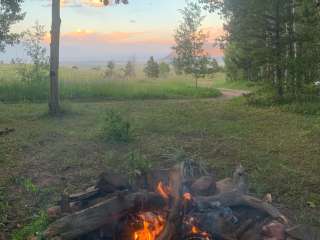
[45, 160, 288, 240]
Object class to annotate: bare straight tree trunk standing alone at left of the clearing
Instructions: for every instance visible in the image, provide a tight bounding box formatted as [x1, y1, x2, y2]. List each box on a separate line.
[49, 0, 61, 115]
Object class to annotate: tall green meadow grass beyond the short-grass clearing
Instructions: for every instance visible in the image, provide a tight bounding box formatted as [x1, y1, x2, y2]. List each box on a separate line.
[0, 65, 220, 102]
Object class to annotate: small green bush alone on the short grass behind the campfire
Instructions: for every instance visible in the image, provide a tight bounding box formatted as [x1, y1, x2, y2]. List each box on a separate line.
[102, 110, 132, 142]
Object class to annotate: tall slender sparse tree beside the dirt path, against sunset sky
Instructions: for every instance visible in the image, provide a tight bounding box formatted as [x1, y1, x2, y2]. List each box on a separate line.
[173, 2, 209, 87]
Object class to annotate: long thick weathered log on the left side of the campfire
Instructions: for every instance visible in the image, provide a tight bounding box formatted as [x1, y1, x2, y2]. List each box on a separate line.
[45, 192, 165, 240]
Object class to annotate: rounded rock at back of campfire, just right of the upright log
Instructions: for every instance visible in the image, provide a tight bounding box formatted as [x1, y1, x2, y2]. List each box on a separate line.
[191, 176, 217, 196]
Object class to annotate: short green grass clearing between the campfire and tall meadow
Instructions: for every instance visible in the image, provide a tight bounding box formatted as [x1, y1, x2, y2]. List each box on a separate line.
[0, 98, 320, 237]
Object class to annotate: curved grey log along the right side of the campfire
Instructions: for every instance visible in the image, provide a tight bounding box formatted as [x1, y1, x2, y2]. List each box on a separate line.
[195, 190, 288, 224]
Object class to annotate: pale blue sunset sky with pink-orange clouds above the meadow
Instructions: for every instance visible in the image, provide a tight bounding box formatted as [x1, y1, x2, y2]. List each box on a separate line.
[0, 0, 222, 62]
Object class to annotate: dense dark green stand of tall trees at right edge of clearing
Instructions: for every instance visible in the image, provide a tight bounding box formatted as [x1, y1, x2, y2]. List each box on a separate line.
[199, 0, 320, 99]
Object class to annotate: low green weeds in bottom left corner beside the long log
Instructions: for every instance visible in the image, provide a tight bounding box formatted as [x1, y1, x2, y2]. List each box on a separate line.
[11, 212, 49, 240]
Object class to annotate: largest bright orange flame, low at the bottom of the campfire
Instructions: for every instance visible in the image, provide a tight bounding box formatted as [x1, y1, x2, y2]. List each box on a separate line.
[133, 213, 165, 240]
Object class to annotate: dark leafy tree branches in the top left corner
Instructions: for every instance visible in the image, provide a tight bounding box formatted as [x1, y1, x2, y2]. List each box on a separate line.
[0, 0, 25, 52]
